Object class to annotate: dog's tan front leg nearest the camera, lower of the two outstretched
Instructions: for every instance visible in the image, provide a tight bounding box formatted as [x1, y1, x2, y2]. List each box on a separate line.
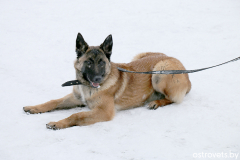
[46, 98, 115, 130]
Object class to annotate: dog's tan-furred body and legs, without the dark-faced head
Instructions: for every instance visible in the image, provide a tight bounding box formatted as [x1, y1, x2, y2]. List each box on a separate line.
[24, 52, 191, 129]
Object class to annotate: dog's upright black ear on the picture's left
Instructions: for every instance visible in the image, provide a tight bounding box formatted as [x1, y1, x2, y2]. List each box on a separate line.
[76, 33, 88, 58]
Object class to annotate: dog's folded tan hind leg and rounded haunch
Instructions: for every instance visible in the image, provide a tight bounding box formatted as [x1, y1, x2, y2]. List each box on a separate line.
[149, 58, 191, 109]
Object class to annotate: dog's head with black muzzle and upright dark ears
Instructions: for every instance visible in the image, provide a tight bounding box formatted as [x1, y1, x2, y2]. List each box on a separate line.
[74, 33, 113, 88]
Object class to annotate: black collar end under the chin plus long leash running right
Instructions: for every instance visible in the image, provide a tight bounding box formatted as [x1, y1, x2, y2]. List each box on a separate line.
[62, 57, 240, 87]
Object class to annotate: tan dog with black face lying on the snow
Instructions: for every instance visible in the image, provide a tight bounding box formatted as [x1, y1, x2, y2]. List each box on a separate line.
[23, 33, 191, 130]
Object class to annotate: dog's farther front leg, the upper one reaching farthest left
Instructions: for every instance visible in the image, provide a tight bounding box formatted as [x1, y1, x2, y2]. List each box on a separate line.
[23, 93, 82, 114]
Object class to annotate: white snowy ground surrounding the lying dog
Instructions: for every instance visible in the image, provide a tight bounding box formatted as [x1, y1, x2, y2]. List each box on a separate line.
[0, 0, 240, 160]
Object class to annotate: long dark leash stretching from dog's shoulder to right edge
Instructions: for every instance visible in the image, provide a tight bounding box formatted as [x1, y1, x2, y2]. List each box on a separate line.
[118, 57, 240, 74]
